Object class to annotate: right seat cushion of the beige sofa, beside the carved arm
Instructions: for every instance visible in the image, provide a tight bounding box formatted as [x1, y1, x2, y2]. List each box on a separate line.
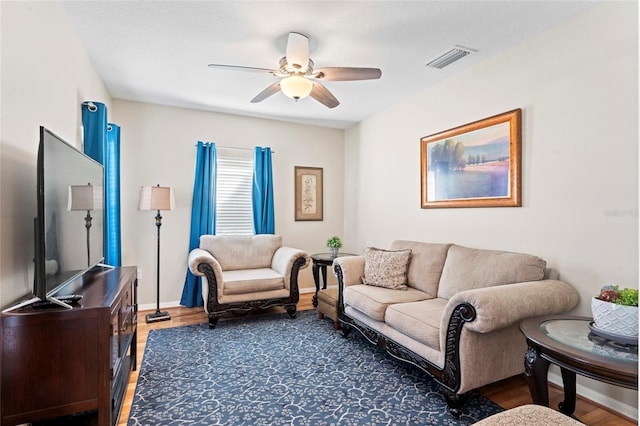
[385, 299, 447, 350]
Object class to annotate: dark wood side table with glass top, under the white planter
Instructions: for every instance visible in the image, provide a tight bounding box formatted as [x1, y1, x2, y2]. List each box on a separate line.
[520, 315, 638, 415]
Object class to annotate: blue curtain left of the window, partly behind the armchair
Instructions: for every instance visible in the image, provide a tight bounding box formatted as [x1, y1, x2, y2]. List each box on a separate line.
[180, 142, 216, 308]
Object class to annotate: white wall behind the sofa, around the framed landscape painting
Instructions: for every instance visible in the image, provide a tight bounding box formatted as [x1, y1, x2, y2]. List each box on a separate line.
[345, 2, 638, 417]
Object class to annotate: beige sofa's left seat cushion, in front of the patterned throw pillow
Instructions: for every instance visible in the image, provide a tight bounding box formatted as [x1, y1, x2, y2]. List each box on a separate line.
[343, 284, 430, 321]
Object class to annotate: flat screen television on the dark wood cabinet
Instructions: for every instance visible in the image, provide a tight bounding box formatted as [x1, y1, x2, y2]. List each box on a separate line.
[33, 126, 104, 301]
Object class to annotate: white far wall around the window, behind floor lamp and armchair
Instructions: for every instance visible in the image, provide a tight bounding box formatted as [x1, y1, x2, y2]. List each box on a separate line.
[111, 99, 344, 305]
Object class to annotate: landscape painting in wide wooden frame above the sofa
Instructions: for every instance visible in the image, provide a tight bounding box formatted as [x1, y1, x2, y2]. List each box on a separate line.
[420, 109, 522, 209]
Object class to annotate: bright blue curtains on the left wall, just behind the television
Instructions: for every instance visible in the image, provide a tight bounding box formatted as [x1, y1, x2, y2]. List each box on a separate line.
[82, 102, 122, 266]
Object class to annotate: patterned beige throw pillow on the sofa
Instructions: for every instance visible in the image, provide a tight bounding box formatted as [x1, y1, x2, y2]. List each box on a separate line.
[362, 247, 411, 290]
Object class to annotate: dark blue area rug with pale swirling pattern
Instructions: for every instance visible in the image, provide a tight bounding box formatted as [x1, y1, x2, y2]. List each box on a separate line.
[128, 311, 502, 426]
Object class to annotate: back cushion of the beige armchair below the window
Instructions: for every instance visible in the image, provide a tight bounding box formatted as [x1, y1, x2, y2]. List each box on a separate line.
[200, 234, 282, 271]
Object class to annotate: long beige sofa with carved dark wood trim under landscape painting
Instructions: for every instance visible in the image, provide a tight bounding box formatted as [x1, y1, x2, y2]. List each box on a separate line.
[333, 241, 578, 415]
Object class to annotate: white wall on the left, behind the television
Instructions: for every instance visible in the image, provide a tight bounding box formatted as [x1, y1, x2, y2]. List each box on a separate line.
[0, 1, 111, 306]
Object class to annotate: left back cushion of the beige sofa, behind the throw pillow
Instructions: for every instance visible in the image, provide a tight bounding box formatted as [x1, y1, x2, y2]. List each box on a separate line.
[391, 240, 451, 297]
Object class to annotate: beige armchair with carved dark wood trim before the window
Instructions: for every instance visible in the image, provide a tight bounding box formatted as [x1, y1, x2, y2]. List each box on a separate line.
[189, 234, 310, 328]
